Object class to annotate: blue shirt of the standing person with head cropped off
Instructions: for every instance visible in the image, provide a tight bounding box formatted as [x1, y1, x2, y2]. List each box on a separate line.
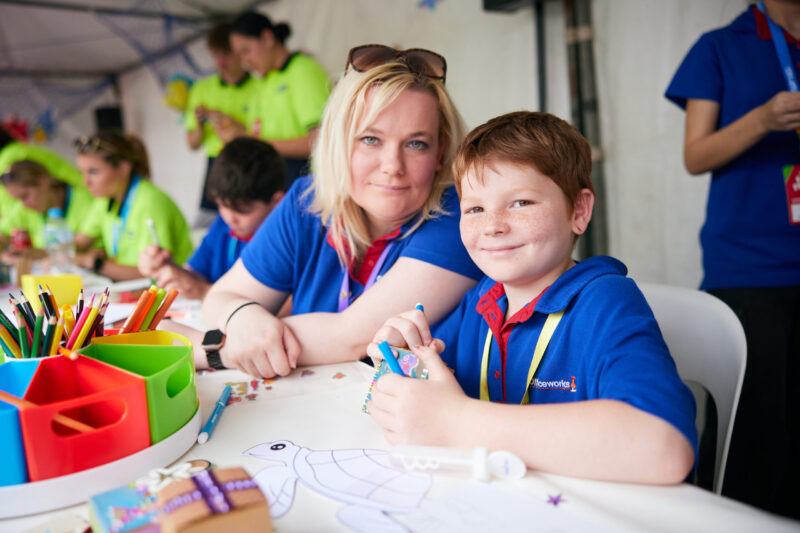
[666, 6, 800, 289]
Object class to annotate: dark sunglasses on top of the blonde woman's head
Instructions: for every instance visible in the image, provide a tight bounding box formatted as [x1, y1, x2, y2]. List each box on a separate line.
[345, 44, 447, 83]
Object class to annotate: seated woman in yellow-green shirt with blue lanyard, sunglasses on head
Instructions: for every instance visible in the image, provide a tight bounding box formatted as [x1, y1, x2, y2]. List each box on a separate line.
[75, 131, 192, 281]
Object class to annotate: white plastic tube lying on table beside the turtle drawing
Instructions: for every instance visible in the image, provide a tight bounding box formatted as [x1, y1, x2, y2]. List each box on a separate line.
[389, 446, 527, 481]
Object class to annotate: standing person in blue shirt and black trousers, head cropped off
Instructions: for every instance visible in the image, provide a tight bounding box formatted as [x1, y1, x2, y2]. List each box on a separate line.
[666, 0, 800, 518]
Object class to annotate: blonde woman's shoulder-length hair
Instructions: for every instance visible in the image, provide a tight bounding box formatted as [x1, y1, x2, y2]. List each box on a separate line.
[304, 61, 464, 265]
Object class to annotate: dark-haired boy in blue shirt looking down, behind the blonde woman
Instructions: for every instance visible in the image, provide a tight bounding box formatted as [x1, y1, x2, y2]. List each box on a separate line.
[139, 137, 286, 299]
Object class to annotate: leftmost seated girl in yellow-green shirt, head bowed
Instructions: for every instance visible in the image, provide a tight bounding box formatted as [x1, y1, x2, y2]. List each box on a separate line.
[0, 160, 95, 249]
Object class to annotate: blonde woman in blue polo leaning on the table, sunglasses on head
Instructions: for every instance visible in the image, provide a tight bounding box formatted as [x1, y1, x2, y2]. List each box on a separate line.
[203, 45, 481, 377]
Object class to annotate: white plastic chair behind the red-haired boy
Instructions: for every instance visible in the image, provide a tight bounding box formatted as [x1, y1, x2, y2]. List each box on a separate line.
[639, 283, 747, 494]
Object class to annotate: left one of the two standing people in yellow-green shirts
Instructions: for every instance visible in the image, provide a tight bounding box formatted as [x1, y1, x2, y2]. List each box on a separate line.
[183, 22, 257, 216]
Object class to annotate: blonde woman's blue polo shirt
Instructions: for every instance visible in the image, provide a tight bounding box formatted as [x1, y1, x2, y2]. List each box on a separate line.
[242, 177, 482, 314]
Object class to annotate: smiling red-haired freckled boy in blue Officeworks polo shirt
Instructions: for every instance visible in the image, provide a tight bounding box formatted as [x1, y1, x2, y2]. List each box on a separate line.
[368, 112, 697, 484]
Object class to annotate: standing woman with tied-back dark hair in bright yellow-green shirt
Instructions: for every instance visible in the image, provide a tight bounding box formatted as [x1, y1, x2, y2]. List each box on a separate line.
[211, 12, 330, 184]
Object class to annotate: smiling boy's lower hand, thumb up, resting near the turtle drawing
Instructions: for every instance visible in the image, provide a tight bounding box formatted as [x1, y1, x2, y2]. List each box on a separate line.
[367, 341, 469, 446]
